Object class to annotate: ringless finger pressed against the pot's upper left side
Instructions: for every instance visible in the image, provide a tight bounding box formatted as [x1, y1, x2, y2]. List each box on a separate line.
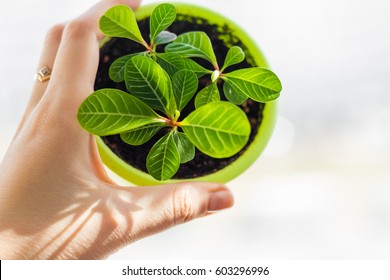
[42, 0, 140, 108]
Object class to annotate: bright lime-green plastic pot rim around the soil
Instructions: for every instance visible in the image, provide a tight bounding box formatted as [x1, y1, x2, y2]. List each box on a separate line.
[97, 3, 277, 186]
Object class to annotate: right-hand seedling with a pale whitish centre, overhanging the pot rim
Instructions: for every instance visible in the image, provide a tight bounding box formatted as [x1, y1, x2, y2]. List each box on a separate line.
[165, 32, 282, 108]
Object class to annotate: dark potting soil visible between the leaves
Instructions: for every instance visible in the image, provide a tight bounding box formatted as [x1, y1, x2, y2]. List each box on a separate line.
[95, 14, 265, 179]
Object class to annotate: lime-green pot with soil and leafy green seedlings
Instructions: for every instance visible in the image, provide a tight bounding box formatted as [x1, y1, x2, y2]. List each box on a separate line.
[78, 3, 282, 185]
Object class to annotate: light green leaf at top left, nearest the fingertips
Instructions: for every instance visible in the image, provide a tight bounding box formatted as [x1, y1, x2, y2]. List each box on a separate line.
[99, 5, 146, 45]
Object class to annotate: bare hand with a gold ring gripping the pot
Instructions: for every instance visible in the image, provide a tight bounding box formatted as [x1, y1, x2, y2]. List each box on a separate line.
[0, 0, 233, 259]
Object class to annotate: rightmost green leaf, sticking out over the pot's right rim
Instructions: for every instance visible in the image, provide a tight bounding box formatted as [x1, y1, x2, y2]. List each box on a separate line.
[222, 67, 282, 102]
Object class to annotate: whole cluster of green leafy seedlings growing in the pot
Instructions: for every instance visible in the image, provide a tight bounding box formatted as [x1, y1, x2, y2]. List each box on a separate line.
[78, 4, 281, 181]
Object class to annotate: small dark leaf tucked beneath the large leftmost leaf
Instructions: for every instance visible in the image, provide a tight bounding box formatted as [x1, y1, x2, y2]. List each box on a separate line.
[120, 123, 164, 146]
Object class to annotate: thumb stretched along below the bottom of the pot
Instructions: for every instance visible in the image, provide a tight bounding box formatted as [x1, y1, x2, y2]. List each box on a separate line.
[126, 183, 234, 241]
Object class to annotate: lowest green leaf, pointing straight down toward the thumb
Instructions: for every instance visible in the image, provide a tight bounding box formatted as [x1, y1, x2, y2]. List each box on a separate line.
[146, 133, 180, 181]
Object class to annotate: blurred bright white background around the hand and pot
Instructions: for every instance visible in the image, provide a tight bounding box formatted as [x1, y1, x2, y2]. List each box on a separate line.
[0, 0, 390, 259]
